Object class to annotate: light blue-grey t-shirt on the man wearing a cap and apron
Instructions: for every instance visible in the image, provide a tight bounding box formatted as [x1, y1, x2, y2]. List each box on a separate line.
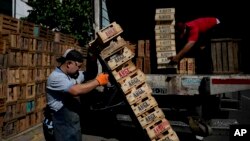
[46, 68, 84, 111]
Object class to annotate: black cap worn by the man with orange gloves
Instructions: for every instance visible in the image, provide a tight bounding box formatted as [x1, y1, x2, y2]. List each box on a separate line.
[56, 49, 83, 63]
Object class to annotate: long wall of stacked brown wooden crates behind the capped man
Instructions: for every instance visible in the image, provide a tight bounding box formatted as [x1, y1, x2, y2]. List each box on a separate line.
[0, 15, 86, 138]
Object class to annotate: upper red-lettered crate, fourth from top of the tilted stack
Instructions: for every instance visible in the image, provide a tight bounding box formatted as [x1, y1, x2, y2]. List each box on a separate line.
[112, 61, 136, 80]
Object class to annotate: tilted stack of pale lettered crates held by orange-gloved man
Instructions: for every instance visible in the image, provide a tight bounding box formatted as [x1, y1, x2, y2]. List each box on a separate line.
[90, 22, 179, 141]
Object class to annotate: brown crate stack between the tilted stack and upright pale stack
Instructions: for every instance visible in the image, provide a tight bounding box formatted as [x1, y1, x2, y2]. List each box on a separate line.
[136, 40, 151, 74]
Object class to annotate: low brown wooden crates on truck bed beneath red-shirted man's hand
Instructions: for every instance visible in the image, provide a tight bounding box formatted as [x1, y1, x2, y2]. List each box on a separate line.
[177, 58, 195, 75]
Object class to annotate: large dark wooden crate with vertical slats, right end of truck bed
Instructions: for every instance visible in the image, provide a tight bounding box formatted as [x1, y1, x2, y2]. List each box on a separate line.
[211, 38, 241, 74]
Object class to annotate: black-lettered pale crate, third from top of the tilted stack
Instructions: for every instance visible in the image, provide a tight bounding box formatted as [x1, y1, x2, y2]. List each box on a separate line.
[105, 47, 135, 70]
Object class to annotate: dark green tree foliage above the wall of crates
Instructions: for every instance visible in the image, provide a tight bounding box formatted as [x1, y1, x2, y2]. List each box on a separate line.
[25, 0, 93, 44]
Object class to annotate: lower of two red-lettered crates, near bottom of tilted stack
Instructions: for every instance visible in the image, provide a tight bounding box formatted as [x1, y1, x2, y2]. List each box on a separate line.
[146, 118, 172, 140]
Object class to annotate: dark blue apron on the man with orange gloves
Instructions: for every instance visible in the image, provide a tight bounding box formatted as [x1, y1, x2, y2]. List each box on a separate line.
[52, 106, 82, 141]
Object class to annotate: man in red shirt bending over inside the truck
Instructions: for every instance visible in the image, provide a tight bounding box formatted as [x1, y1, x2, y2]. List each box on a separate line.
[169, 17, 220, 72]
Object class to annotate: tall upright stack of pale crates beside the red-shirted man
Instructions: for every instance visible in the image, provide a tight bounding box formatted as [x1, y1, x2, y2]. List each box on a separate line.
[155, 8, 177, 69]
